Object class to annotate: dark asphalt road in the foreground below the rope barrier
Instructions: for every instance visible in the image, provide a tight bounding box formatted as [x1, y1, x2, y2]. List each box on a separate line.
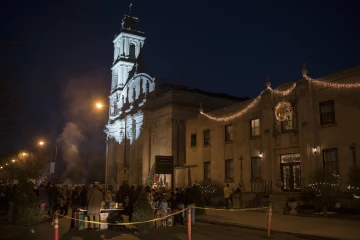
[30, 219, 326, 240]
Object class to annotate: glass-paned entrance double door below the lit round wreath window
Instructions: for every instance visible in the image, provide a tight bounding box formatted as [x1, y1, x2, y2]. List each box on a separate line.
[280, 153, 301, 192]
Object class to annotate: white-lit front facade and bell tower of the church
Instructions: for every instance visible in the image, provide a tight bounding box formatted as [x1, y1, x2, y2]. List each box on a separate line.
[105, 5, 155, 184]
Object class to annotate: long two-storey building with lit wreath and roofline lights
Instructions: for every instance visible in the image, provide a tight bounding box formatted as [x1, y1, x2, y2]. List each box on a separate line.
[186, 66, 360, 212]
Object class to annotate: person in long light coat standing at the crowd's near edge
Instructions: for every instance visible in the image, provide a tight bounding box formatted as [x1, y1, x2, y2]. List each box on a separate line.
[87, 182, 103, 230]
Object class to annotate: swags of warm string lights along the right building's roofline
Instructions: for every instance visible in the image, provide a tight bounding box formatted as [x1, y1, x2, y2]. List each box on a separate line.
[200, 70, 360, 122]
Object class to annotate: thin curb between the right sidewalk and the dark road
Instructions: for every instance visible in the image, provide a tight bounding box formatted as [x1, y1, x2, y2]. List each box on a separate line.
[196, 218, 349, 240]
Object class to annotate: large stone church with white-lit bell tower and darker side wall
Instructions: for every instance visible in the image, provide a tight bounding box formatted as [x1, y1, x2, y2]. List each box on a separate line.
[105, 12, 244, 188]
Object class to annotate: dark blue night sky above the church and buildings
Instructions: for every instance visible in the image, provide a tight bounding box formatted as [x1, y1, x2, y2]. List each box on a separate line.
[0, 0, 360, 155]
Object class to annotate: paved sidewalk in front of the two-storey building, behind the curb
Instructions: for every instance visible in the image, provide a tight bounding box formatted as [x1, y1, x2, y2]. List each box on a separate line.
[196, 209, 360, 240]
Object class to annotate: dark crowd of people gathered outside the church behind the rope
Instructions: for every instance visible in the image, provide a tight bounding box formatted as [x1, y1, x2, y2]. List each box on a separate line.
[0, 181, 193, 228]
